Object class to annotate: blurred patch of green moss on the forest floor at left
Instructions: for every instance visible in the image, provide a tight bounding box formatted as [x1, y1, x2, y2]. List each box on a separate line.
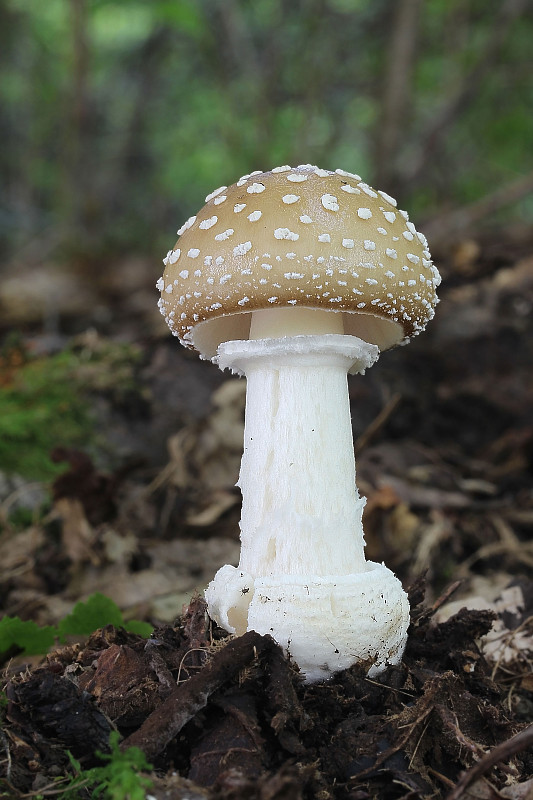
[0, 333, 139, 480]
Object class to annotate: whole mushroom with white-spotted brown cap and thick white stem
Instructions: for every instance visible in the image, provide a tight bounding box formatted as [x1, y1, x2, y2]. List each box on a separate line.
[158, 164, 440, 682]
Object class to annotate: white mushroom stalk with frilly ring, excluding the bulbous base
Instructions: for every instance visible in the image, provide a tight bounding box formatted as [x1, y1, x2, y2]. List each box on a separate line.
[219, 334, 372, 577]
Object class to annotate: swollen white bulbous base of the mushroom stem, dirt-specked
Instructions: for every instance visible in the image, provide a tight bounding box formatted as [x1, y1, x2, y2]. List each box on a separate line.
[206, 561, 409, 683]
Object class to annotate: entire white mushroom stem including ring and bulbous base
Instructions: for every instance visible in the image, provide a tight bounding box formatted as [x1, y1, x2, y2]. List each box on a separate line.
[206, 309, 408, 681]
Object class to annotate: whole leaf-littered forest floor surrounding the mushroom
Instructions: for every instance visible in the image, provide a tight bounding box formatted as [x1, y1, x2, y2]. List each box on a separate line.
[0, 232, 533, 800]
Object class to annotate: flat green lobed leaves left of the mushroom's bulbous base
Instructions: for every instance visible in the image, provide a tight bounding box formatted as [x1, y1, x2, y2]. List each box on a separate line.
[0, 592, 152, 656]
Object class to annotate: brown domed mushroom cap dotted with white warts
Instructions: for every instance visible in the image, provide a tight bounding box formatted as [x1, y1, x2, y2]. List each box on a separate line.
[158, 165, 440, 358]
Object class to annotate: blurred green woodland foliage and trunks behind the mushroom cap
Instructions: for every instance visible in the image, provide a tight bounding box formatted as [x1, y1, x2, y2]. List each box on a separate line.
[0, 0, 533, 260]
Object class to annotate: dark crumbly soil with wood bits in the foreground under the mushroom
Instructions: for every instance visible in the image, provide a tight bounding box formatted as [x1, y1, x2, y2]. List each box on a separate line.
[3, 581, 533, 800]
